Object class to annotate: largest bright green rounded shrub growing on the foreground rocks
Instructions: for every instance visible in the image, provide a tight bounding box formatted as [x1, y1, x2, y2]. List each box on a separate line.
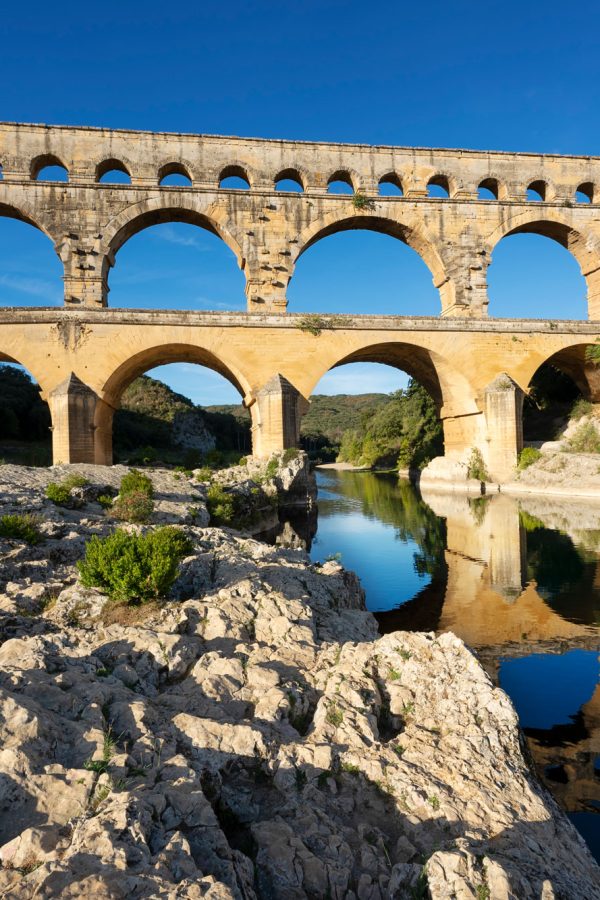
[78, 526, 193, 603]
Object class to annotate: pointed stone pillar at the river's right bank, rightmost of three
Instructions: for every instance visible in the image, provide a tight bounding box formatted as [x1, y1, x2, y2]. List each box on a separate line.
[481, 373, 523, 482]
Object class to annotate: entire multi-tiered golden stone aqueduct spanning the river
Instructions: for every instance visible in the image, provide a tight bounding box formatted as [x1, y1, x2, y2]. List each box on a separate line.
[0, 123, 600, 480]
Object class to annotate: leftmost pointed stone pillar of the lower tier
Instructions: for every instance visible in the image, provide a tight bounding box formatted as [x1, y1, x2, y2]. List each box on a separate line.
[48, 372, 97, 465]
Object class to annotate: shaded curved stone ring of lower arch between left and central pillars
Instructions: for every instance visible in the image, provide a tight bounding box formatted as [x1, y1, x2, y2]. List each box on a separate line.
[94, 343, 251, 465]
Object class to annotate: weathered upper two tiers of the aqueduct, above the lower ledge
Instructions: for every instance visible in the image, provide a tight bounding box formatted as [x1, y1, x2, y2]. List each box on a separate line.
[0, 123, 600, 320]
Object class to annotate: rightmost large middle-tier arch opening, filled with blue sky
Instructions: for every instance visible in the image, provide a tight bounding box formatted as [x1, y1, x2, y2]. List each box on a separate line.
[488, 227, 590, 319]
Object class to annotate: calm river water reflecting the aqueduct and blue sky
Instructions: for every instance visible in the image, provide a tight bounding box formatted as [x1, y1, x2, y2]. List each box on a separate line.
[274, 469, 600, 861]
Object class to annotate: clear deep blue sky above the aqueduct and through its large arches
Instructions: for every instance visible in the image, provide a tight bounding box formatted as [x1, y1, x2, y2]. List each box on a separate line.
[0, 0, 600, 404]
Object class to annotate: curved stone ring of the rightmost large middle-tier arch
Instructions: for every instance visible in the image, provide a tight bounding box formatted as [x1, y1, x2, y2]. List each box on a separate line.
[484, 209, 600, 320]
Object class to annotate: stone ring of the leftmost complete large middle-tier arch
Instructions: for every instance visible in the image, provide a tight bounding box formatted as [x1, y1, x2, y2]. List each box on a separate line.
[98, 193, 246, 306]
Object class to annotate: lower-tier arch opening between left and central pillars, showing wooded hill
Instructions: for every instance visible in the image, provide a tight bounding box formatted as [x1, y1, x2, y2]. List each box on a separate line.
[95, 345, 252, 468]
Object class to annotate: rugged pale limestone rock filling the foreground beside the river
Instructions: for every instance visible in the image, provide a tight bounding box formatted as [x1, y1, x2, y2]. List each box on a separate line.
[0, 466, 600, 900]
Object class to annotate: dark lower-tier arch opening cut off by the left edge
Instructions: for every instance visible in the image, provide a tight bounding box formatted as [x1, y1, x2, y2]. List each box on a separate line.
[0, 362, 52, 466]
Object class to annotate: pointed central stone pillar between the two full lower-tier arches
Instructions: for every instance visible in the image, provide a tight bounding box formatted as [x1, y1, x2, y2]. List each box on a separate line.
[252, 374, 308, 457]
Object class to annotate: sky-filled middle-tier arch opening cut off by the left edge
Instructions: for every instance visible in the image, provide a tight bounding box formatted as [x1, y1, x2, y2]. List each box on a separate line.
[0, 209, 64, 306]
